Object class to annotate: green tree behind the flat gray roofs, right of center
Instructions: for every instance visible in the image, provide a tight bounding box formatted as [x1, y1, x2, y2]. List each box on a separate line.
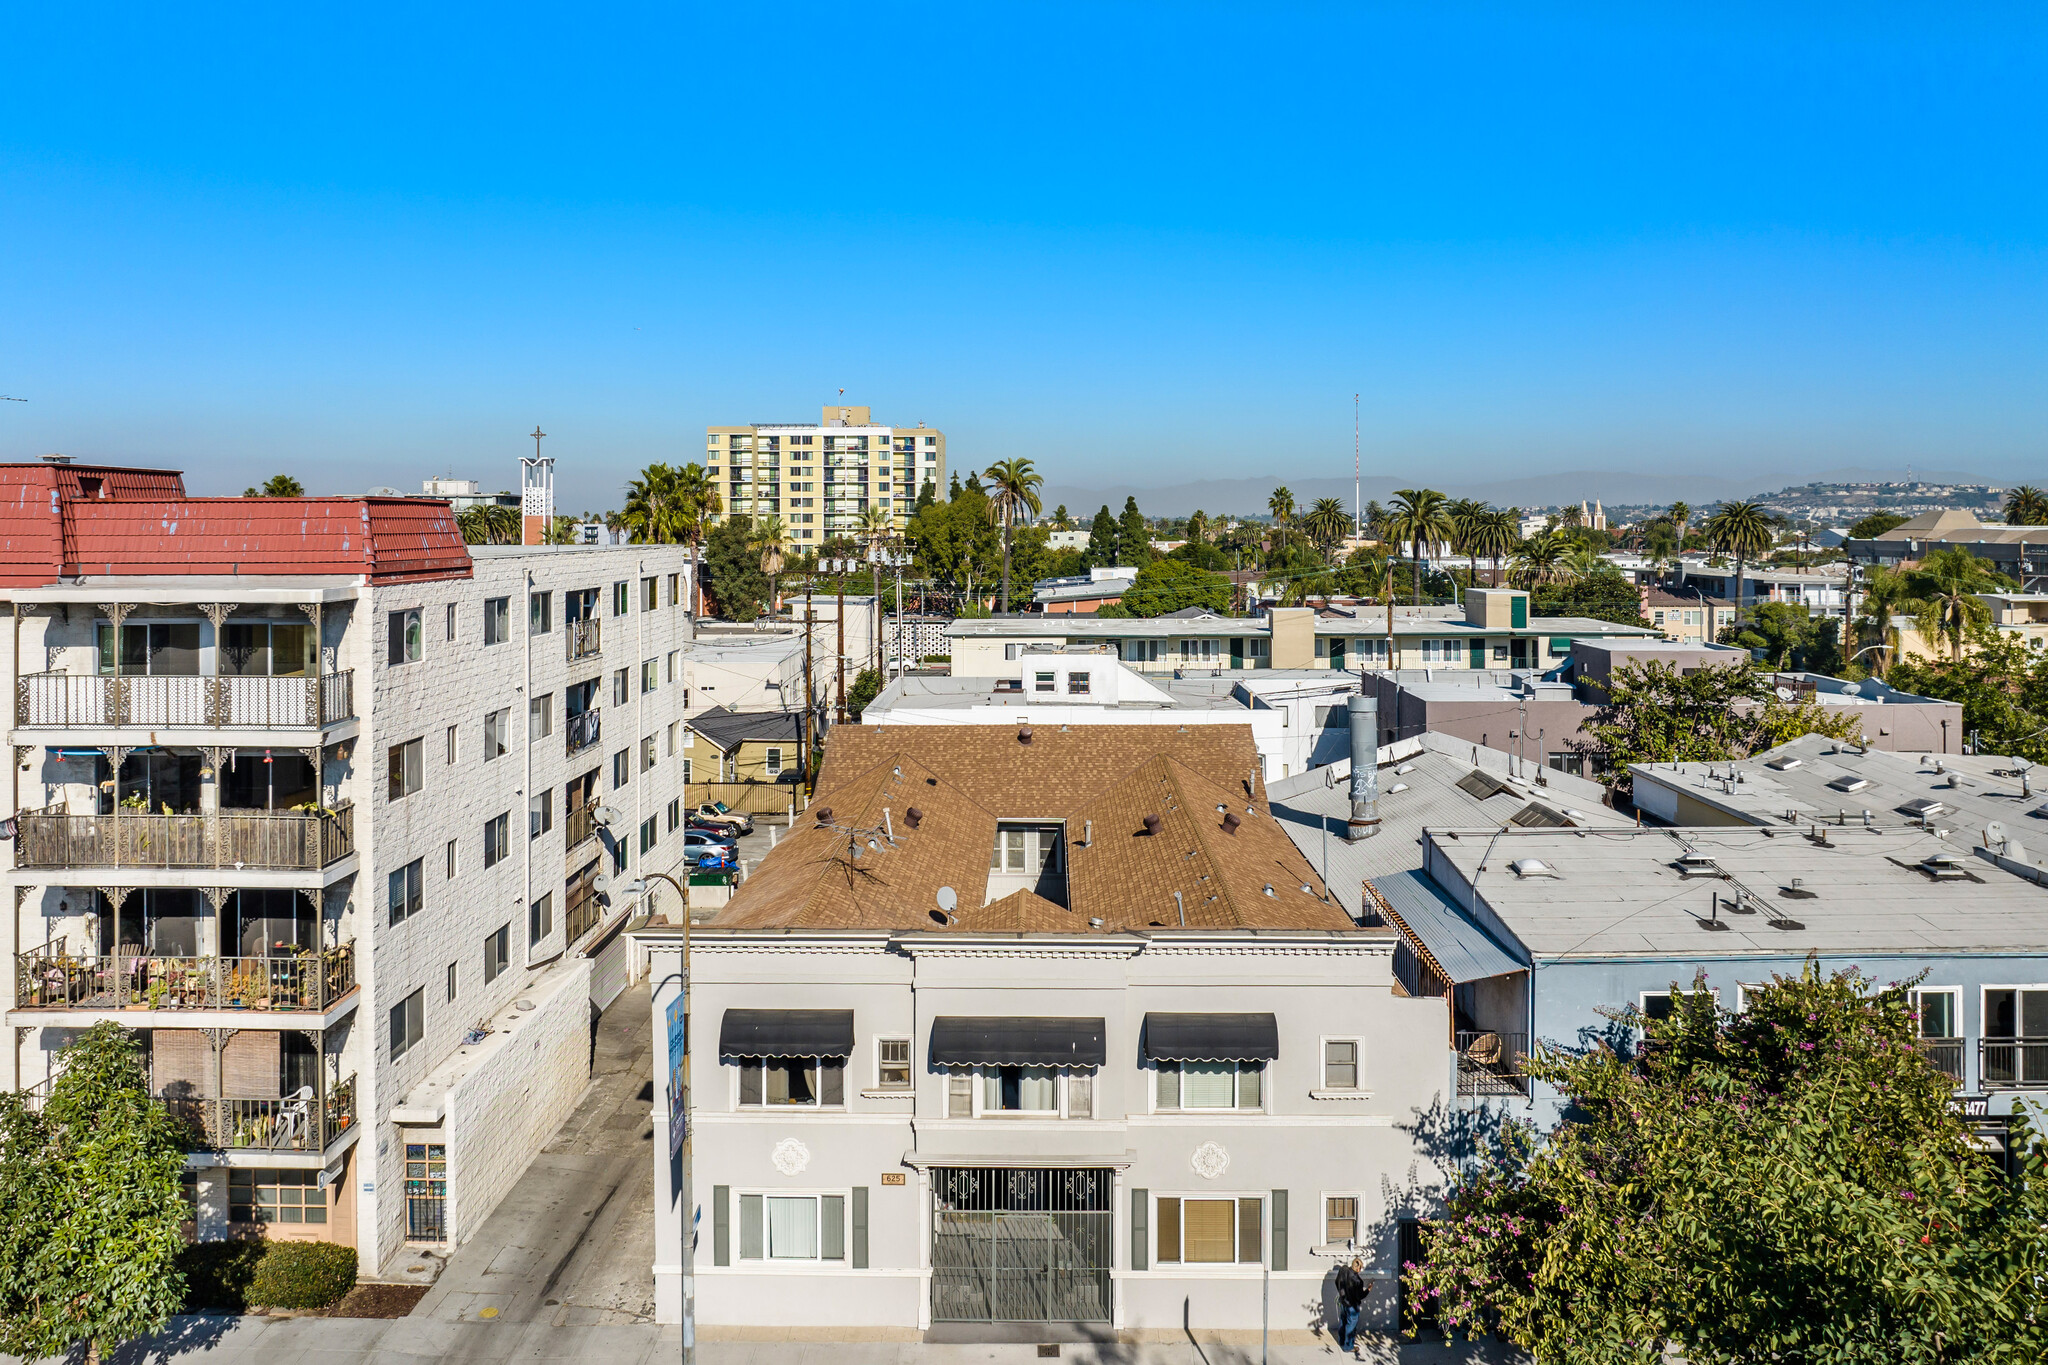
[1585, 657, 1858, 790]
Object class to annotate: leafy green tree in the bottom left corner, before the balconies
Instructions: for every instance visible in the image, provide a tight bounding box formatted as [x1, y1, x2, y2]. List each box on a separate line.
[0, 1019, 186, 1361]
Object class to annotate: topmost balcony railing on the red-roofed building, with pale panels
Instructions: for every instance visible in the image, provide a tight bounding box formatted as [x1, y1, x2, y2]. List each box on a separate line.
[14, 669, 356, 731]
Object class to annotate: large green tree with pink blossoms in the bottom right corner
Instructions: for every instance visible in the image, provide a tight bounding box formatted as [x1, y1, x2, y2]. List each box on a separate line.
[1405, 962, 2048, 1365]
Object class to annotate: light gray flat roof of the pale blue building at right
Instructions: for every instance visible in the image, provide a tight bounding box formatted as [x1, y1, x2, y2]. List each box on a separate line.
[1427, 825, 2048, 962]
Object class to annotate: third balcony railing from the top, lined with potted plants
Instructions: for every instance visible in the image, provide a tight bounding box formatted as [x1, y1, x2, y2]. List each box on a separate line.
[14, 937, 356, 1013]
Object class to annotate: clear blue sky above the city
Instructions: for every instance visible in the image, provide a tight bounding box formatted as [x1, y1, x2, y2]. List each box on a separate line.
[0, 2, 2048, 510]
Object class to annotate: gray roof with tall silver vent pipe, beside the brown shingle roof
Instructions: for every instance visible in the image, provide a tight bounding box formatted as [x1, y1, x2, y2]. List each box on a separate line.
[1266, 731, 1630, 919]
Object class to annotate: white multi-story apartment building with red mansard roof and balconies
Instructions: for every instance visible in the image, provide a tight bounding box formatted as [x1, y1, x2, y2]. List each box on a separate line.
[0, 465, 690, 1269]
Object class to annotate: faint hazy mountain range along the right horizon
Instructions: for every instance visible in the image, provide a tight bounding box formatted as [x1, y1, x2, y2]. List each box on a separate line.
[1040, 469, 1995, 524]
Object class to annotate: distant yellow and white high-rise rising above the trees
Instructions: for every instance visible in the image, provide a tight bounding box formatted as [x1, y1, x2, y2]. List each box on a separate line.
[705, 407, 946, 548]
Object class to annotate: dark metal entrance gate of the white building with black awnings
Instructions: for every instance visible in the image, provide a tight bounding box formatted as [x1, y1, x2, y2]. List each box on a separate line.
[932, 1166, 1114, 1322]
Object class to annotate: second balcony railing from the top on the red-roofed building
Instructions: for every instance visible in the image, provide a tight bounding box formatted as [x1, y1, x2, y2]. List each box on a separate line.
[14, 802, 356, 872]
